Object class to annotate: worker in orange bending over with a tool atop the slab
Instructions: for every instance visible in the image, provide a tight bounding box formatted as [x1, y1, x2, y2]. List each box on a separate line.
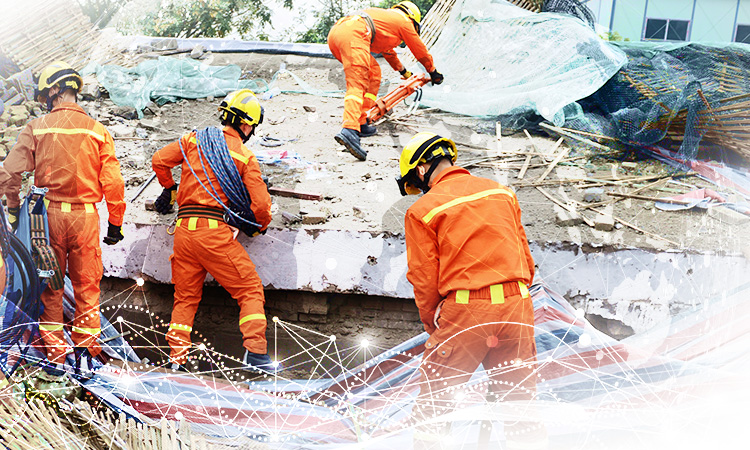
[328, 1, 443, 161]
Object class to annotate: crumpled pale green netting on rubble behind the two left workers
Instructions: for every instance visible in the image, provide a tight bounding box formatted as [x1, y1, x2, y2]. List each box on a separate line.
[83, 56, 268, 117]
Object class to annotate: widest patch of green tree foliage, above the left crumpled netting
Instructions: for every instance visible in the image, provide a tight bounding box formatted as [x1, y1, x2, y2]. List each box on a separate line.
[125, 0, 292, 38]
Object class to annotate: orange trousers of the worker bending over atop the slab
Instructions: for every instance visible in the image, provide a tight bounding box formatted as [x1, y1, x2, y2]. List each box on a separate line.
[328, 18, 381, 131]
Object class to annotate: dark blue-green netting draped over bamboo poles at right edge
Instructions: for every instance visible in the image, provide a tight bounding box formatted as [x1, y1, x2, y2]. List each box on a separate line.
[566, 42, 750, 163]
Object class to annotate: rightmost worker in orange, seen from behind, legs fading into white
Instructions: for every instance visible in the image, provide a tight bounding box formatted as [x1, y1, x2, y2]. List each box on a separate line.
[398, 133, 546, 448]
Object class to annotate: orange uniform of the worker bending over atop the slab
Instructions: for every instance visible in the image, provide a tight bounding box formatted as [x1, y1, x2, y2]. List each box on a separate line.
[328, 8, 435, 131]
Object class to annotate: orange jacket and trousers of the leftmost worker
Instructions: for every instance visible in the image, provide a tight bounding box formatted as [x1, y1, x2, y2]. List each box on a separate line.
[0, 103, 125, 363]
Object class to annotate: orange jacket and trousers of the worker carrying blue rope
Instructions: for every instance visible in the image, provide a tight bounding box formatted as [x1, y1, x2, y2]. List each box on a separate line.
[152, 127, 271, 364]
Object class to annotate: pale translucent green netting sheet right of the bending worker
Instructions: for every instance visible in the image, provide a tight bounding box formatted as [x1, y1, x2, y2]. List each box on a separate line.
[414, 0, 627, 125]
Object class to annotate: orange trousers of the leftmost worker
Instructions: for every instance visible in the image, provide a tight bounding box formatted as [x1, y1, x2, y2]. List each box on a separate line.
[39, 201, 104, 363]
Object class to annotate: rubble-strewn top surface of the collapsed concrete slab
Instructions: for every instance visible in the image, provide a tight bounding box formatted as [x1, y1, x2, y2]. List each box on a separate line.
[82, 53, 750, 254]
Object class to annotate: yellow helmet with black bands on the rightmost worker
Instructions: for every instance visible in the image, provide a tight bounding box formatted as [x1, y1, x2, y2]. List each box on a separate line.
[396, 132, 458, 195]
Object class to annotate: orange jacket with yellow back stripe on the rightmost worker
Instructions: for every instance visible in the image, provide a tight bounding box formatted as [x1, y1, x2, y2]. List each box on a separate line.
[406, 166, 534, 297]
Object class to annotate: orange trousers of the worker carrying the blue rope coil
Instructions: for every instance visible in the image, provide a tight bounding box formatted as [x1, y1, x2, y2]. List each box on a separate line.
[167, 218, 267, 364]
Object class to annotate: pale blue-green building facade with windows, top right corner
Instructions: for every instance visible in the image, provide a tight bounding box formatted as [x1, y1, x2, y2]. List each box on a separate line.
[584, 0, 750, 44]
